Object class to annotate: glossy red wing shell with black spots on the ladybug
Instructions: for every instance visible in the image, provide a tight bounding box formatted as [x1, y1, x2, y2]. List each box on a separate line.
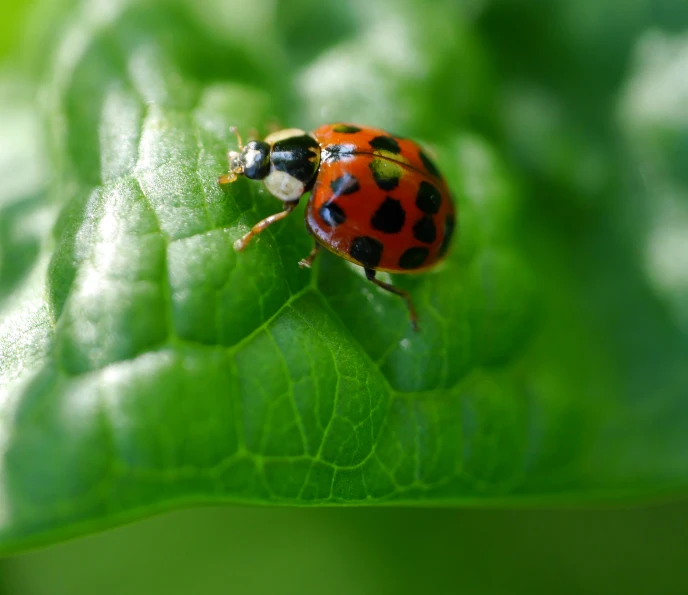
[306, 124, 456, 273]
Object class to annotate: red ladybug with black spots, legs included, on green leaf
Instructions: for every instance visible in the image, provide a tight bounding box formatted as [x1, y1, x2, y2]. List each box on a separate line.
[218, 124, 455, 330]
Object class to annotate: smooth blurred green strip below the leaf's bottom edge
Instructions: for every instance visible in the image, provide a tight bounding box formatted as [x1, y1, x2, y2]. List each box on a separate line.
[2, 505, 688, 595]
